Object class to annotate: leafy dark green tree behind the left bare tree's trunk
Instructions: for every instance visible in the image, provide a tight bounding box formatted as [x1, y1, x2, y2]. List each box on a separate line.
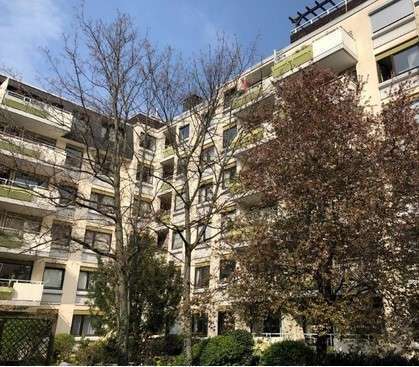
[90, 237, 182, 363]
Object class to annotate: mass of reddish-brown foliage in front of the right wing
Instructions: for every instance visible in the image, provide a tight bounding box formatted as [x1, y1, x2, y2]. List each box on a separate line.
[230, 68, 418, 356]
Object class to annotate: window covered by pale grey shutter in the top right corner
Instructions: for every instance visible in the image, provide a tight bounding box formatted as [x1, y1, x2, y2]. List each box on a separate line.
[370, 0, 413, 33]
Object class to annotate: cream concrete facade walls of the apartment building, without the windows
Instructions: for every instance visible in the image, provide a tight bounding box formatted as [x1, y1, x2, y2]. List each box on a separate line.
[0, 0, 419, 346]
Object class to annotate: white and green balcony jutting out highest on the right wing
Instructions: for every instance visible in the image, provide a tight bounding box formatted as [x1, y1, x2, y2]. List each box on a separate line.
[272, 27, 358, 78]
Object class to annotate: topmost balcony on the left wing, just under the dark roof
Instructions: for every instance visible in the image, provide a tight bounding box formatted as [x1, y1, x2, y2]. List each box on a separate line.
[0, 91, 73, 138]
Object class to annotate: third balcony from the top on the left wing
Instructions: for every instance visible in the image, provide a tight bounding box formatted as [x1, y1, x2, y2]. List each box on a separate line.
[0, 179, 58, 216]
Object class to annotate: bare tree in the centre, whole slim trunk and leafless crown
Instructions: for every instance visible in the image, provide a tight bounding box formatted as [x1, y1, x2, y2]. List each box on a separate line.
[147, 35, 265, 363]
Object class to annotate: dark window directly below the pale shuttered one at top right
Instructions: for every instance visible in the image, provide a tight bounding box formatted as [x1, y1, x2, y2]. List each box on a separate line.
[377, 40, 419, 82]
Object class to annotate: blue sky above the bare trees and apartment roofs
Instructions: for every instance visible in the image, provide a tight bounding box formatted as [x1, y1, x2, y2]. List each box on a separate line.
[0, 0, 313, 84]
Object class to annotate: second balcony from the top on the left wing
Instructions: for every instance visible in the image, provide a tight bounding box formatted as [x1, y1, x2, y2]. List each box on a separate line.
[0, 133, 66, 175]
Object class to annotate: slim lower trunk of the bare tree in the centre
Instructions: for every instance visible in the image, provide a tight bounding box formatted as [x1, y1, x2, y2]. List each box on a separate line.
[182, 246, 192, 365]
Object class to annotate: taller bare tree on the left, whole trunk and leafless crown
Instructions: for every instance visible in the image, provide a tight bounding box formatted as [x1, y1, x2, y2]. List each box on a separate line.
[2, 12, 160, 364]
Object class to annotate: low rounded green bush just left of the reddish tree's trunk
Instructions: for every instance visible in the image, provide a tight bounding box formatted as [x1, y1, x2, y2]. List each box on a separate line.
[261, 340, 316, 366]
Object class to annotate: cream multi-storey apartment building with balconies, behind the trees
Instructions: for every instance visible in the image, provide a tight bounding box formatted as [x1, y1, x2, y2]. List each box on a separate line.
[0, 0, 419, 343]
